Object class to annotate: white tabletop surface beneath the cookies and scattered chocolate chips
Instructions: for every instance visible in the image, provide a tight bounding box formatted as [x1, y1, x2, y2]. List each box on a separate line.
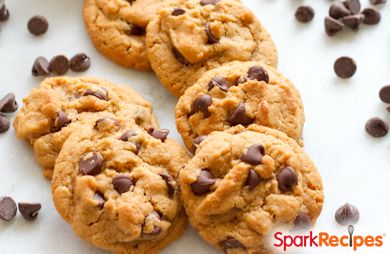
[0, 0, 390, 254]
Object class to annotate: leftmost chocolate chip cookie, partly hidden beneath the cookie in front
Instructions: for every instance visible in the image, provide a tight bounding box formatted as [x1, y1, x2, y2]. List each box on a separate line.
[14, 77, 158, 178]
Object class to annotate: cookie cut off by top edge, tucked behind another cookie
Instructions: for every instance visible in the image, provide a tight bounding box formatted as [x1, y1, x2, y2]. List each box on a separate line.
[84, 0, 172, 71]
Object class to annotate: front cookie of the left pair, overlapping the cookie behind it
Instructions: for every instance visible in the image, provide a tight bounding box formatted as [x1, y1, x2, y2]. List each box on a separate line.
[52, 117, 189, 254]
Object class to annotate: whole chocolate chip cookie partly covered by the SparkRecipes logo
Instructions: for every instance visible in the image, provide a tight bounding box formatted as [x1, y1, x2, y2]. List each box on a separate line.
[179, 125, 324, 254]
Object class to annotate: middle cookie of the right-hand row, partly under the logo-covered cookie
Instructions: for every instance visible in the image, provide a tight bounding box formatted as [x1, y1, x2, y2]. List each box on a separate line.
[176, 62, 305, 151]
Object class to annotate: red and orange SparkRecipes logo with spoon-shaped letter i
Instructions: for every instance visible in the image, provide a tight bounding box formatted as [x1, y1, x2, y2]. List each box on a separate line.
[274, 225, 385, 251]
